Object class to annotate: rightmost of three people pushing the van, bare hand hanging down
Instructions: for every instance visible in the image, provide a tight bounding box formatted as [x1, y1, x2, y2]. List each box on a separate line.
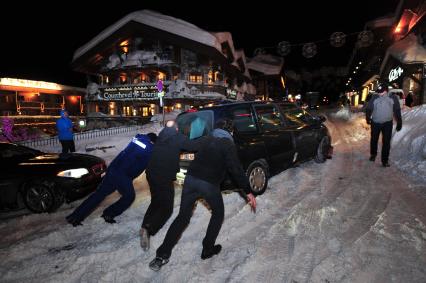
[149, 120, 256, 271]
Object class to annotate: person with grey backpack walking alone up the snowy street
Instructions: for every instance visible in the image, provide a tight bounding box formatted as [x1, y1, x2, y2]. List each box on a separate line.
[366, 84, 402, 167]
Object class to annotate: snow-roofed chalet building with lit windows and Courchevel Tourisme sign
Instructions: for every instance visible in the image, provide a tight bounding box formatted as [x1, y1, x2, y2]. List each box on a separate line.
[72, 10, 255, 117]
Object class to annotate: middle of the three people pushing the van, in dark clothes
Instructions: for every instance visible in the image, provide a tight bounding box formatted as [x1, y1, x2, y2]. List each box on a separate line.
[139, 120, 203, 251]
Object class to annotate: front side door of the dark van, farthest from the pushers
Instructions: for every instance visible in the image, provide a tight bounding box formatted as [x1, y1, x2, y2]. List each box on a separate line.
[282, 107, 320, 160]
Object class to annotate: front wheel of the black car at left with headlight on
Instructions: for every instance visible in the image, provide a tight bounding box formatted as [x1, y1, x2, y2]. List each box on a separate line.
[22, 182, 64, 213]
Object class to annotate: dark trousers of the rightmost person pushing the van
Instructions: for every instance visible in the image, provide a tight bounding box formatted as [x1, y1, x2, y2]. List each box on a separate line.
[157, 175, 224, 258]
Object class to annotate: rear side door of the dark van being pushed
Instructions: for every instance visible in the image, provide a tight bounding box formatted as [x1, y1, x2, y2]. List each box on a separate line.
[254, 103, 295, 169]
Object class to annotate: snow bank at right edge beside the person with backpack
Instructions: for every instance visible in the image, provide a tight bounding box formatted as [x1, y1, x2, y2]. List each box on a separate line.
[391, 105, 426, 183]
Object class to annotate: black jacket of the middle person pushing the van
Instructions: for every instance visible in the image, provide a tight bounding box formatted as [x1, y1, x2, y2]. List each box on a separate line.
[146, 127, 199, 182]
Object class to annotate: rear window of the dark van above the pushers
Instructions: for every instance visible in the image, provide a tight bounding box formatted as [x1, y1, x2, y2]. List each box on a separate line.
[177, 110, 213, 139]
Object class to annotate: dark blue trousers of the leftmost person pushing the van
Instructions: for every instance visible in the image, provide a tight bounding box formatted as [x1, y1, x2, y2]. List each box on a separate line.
[69, 170, 135, 221]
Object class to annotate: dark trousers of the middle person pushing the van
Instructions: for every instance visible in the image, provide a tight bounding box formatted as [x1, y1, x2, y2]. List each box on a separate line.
[142, 174, 175, 236]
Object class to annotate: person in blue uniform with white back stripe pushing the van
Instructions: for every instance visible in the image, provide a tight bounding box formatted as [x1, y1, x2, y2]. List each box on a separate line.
[66, 133, 157, 226]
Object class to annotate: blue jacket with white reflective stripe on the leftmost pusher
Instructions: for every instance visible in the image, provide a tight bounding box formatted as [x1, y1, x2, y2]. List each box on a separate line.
[109, 134, 153, 179]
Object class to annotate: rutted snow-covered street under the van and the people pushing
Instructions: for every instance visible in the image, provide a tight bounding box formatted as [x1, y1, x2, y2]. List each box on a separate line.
[0, 106, 426, 282]
